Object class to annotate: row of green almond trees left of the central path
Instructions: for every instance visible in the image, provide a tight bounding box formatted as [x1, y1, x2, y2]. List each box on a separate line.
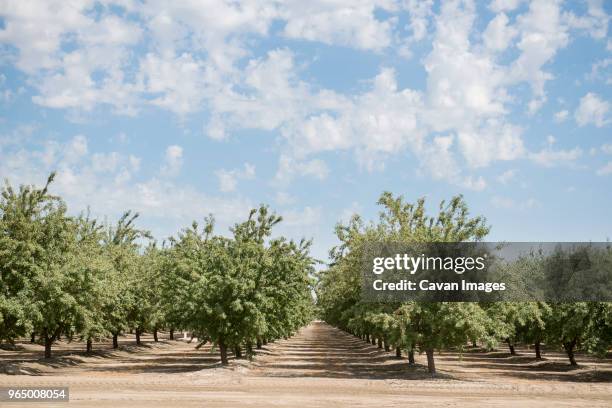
[0, 175, 313, 364]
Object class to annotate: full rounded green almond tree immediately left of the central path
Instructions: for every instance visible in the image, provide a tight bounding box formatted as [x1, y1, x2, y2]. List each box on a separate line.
[161, 206, 313, 363]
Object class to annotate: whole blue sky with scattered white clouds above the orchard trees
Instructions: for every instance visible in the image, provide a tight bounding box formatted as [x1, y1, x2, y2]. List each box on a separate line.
[0, 0, 612, 260]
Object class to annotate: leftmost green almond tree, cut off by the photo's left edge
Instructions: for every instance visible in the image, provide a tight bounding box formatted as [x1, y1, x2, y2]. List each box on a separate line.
[2, 174, 98, 358]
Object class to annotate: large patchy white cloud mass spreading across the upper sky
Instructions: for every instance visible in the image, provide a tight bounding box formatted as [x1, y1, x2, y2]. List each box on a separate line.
[0, 0, 608, 190]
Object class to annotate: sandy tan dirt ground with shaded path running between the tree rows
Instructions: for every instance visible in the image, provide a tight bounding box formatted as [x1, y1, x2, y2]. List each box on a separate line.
[0, 322, 612, 408]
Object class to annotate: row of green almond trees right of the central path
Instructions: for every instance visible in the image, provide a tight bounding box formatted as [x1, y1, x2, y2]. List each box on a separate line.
[317, 192, 612, 375]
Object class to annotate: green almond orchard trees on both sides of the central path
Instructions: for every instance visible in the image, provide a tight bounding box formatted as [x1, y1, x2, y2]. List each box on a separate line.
[0, 174, 612, 375]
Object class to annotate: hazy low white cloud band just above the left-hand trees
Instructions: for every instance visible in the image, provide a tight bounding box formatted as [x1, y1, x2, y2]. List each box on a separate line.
[0, 135, 253, 239]
